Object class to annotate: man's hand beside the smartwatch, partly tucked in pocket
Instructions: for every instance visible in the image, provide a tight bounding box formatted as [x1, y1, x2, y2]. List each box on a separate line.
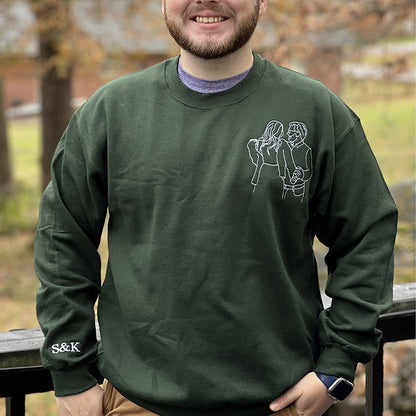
[270, 373, 335, 416]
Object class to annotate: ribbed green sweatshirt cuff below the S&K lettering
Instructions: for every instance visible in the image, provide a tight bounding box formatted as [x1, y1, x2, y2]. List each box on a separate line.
[51, 364, 97, 397]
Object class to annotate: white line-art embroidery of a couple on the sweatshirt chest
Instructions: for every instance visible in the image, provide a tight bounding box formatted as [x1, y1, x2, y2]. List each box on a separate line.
[247, 120, 313, 202]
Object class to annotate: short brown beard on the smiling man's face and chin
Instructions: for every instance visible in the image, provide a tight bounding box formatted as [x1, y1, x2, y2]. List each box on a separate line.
[165, 0, 260, 59]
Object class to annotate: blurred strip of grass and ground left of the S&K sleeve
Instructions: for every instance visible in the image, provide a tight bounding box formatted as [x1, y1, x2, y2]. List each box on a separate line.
[0, 119, 41, 324]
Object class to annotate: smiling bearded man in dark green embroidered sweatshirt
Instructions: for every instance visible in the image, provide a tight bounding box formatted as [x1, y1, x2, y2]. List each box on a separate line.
[35, 0, 397, 416]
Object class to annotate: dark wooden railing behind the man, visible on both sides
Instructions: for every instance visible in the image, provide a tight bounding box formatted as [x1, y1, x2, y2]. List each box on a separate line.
[0, 283, 416, 416]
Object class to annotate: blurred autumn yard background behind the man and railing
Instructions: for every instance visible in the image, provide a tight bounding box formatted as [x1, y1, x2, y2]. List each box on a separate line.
[0, 0, 416, 416]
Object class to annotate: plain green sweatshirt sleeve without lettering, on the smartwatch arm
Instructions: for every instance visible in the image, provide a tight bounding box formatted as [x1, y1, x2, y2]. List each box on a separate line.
[314, 120, 397, 380]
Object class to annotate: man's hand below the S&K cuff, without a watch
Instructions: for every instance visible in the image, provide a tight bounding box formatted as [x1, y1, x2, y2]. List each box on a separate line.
[56, 384, 103, 416]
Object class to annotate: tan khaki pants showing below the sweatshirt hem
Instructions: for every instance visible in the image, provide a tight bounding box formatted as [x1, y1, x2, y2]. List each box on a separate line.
[103, 380, 298, 416]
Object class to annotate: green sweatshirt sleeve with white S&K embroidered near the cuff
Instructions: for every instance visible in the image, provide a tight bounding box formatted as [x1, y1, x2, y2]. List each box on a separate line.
[35, 102, 107, 396]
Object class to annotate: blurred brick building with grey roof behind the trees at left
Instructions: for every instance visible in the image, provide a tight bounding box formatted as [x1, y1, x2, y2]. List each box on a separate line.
[0, 0, 175, 112]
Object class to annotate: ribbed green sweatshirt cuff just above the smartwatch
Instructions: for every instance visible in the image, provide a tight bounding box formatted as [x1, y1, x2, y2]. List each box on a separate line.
[315, 346, 358, 382]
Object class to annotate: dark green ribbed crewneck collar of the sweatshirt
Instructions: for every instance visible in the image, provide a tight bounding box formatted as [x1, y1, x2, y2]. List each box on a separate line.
[165, 53, 267, 108]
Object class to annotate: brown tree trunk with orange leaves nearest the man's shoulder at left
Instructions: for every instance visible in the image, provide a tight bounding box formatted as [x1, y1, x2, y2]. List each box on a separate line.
[29, 0, 162, 187]
